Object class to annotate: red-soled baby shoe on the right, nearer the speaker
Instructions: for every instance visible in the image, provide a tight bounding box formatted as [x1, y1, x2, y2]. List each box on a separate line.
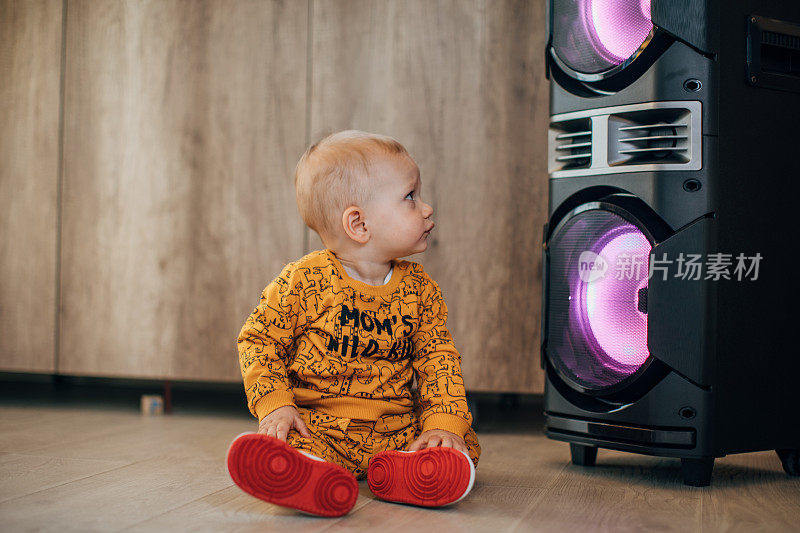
[367, 447, 475, 507]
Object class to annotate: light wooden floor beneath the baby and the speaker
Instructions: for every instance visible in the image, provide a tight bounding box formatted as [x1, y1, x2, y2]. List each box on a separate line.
[0, 402, 800, 533]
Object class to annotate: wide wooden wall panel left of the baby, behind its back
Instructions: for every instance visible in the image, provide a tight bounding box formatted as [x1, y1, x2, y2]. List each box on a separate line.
[59, 0, 308, 381]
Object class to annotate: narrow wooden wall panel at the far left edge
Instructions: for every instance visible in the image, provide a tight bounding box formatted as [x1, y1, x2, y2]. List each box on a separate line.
[0, 0, 62, 372]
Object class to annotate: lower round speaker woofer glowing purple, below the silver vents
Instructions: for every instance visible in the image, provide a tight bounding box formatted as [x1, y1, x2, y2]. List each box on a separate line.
[546, 202, 652, 395]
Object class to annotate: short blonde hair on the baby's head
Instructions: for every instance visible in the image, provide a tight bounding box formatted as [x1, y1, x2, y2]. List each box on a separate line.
[294, 130, 408, 236]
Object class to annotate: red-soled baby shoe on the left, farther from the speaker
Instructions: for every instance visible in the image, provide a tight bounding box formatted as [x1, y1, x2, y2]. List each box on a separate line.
[227, 433, 358, 516]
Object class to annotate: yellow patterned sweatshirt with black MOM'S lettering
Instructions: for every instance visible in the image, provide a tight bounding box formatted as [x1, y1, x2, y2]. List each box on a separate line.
[238, 250, 472, 436]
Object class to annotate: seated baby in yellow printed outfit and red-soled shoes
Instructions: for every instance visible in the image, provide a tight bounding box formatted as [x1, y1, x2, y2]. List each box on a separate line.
[227, 130, 480, 516]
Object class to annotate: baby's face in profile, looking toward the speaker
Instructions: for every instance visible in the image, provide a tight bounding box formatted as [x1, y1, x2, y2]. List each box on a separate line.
[364, 155, 433, 259]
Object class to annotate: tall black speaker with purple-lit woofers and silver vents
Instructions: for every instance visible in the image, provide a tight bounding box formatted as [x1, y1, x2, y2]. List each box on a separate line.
[541, 0, 800, 486]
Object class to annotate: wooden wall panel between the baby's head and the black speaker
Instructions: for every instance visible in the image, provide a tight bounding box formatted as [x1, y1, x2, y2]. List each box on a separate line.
[311, 0, 548, 392]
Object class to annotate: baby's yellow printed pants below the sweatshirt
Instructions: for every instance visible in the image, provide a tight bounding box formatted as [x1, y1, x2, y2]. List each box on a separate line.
[286, 407, 481, 479]
